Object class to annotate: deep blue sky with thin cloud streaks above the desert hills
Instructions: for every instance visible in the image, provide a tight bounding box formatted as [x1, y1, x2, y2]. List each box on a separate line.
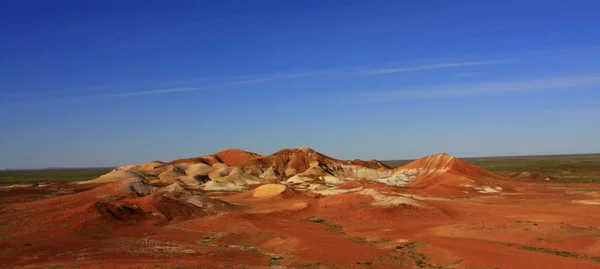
[0, 0, 600, 168]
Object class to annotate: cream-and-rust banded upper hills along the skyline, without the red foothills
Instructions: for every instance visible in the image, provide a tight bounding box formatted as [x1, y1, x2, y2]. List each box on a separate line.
[81, 147, 503, 195]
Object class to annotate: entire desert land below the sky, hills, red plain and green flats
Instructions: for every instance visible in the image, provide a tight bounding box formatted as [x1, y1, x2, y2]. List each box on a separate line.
[0, 148, 600, 269]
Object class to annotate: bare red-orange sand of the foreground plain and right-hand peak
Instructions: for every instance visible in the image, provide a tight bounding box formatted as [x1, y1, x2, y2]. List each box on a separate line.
[0, 152, 600, 269]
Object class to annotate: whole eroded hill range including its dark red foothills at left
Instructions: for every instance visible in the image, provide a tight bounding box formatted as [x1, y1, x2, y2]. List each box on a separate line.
[14, 148, 508, 228]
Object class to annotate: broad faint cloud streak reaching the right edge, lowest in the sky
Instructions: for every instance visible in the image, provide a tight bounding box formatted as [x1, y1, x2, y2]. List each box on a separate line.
[355, 74, 600, 103]
